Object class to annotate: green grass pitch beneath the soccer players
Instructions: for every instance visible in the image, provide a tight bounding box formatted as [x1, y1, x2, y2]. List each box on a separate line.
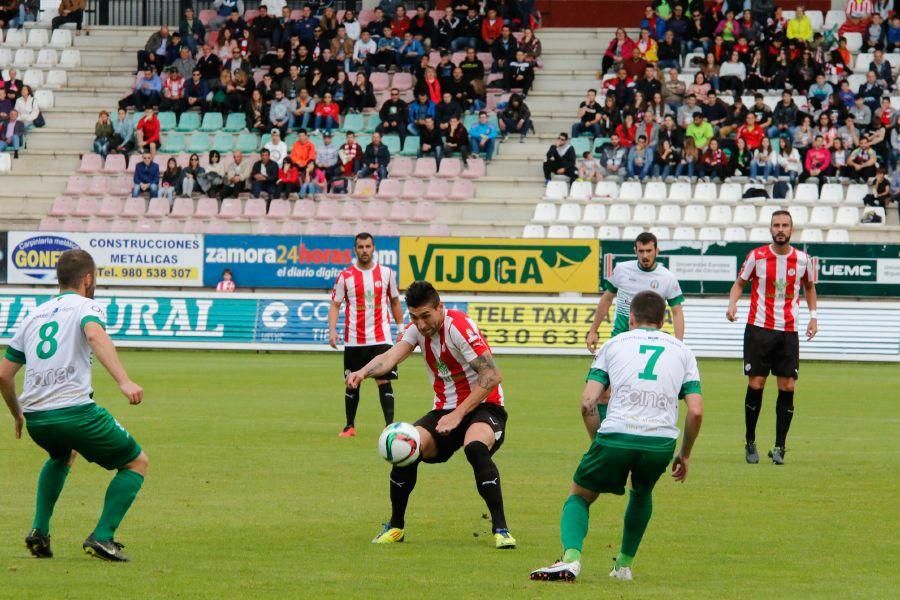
[0, 351, 900, 599]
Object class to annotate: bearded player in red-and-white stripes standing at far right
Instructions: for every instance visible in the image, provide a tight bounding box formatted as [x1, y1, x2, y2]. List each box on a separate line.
[725, 210, 819, 465]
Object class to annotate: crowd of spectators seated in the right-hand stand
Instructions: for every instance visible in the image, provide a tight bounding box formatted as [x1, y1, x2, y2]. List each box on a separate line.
[544, 0, 900, 218]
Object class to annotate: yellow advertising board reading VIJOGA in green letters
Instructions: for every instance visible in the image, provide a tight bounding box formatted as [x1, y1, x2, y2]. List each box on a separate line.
[400, 237, 600, 293]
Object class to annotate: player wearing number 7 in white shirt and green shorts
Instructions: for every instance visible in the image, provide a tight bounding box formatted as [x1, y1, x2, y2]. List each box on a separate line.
[531, 291, 703, 581]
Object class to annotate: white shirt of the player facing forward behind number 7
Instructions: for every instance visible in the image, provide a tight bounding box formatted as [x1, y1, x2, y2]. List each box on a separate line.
[605, 260, 684, 337]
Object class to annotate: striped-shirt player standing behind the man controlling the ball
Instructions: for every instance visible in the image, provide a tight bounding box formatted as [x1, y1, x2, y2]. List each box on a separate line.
[328, 232, 403, 437]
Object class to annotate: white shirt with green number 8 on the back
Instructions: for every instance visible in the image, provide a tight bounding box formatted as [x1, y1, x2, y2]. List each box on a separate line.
[6, 292, 106, 413]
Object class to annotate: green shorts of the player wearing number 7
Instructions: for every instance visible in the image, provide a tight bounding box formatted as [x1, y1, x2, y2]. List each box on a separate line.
[572, 434, 675, 496]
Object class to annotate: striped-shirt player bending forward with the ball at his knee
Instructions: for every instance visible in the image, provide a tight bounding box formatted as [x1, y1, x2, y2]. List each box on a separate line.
[347, 281, 516, 550]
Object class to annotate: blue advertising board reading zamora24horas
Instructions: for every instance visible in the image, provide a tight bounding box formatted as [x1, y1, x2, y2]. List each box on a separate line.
[203, 235, 400, 289]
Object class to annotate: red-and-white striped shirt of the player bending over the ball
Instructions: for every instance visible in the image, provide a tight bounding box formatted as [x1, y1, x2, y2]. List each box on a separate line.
[403, 309, 503, 410]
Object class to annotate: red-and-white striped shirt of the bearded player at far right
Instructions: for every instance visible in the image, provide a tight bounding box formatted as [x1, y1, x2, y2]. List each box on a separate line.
[740, 245, 817, 332]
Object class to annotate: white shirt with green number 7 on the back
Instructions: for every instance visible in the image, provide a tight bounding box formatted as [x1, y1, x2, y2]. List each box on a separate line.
[588, 329, 700, 449]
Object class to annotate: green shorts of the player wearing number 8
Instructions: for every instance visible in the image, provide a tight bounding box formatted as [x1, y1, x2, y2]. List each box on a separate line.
[25, 403, 141, 470]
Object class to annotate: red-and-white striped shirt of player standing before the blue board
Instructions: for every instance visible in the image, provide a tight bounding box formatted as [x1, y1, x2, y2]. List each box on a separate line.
[331, 263, 400, 346]
